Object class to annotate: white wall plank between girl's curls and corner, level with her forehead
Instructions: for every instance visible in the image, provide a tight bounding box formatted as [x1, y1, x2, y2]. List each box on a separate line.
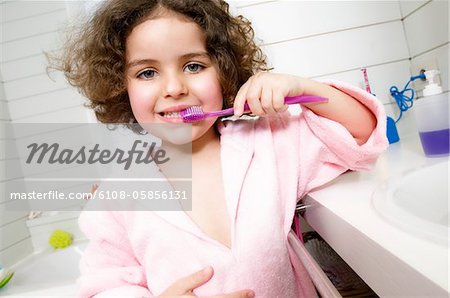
[264, 21, 408, 77]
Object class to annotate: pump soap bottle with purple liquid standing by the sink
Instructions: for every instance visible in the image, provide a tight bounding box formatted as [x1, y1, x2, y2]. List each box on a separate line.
[413, 70, 450, 157]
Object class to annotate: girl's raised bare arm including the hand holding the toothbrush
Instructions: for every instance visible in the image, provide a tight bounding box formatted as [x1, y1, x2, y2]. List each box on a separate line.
[234, 72, 377, 145]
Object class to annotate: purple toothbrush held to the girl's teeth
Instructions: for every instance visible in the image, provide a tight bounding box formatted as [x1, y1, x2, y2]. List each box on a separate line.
[180, 95, 328, 123]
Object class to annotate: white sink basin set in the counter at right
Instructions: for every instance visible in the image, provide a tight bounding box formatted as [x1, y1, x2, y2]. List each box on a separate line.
[372, 159, 449, 245]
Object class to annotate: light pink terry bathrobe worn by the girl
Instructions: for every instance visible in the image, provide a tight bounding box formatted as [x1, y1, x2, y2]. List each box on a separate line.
[78, 82, 387, 298]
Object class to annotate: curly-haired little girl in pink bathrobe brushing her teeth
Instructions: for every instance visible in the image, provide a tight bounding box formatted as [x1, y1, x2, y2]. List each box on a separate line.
[56, 0, 387, 298]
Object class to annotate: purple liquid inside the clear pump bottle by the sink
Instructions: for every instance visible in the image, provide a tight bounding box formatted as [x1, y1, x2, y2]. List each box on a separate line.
[419, 128, 450, 156]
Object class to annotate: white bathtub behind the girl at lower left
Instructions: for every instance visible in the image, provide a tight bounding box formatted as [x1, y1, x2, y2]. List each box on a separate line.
[0, 241, 87, 298]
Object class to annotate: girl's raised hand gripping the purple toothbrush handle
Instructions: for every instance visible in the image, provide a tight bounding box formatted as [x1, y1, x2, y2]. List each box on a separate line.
[234, 72, 304, 117]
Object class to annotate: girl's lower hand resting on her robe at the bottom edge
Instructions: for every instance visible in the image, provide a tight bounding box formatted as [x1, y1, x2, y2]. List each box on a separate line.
[159, 267, 255, 298]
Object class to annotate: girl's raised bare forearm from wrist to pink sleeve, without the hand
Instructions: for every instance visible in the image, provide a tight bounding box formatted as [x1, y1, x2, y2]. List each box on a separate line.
[299, 78, 377, 145]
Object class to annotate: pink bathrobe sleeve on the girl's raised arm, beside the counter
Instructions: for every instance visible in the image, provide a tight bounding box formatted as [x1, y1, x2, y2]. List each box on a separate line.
[298, 81, 388, 198]
